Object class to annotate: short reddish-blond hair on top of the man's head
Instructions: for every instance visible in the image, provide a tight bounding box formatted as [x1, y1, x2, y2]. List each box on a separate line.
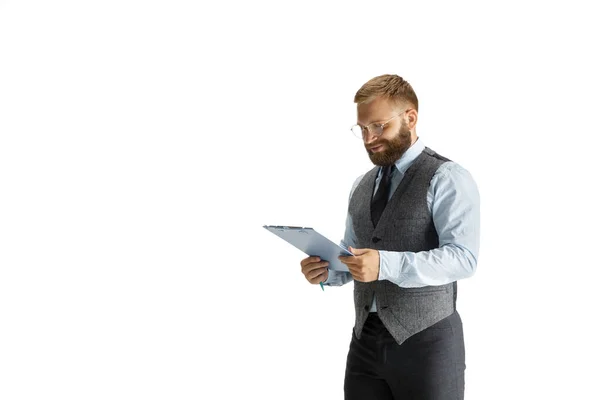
[354, 75, 419, 111]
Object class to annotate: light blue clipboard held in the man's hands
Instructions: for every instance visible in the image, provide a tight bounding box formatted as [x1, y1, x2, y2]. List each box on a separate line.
[263, 225, 354, 272]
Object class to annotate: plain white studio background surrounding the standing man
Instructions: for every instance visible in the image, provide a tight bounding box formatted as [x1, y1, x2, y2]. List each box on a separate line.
[0, 0, 600, 400]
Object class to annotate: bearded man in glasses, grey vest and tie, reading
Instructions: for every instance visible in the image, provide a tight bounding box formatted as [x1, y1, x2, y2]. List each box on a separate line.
[301, 75, 479, 400]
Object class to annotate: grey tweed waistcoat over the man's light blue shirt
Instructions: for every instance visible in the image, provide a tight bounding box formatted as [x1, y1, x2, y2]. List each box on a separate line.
[348, 147, 456, 344]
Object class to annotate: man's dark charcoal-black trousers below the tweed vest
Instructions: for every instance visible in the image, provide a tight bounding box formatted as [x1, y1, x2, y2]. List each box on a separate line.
[344, 312, 465, 400]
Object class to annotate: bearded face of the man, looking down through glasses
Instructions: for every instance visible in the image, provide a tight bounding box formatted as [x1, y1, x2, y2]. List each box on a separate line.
[357, 98, 412, 166]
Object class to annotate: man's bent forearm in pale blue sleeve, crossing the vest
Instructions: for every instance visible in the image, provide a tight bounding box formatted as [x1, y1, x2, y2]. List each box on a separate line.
[379, 244, 477, 288]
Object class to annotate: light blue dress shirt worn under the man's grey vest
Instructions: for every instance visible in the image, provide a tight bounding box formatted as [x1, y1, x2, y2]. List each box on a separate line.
[323, 139, 479, 311]
